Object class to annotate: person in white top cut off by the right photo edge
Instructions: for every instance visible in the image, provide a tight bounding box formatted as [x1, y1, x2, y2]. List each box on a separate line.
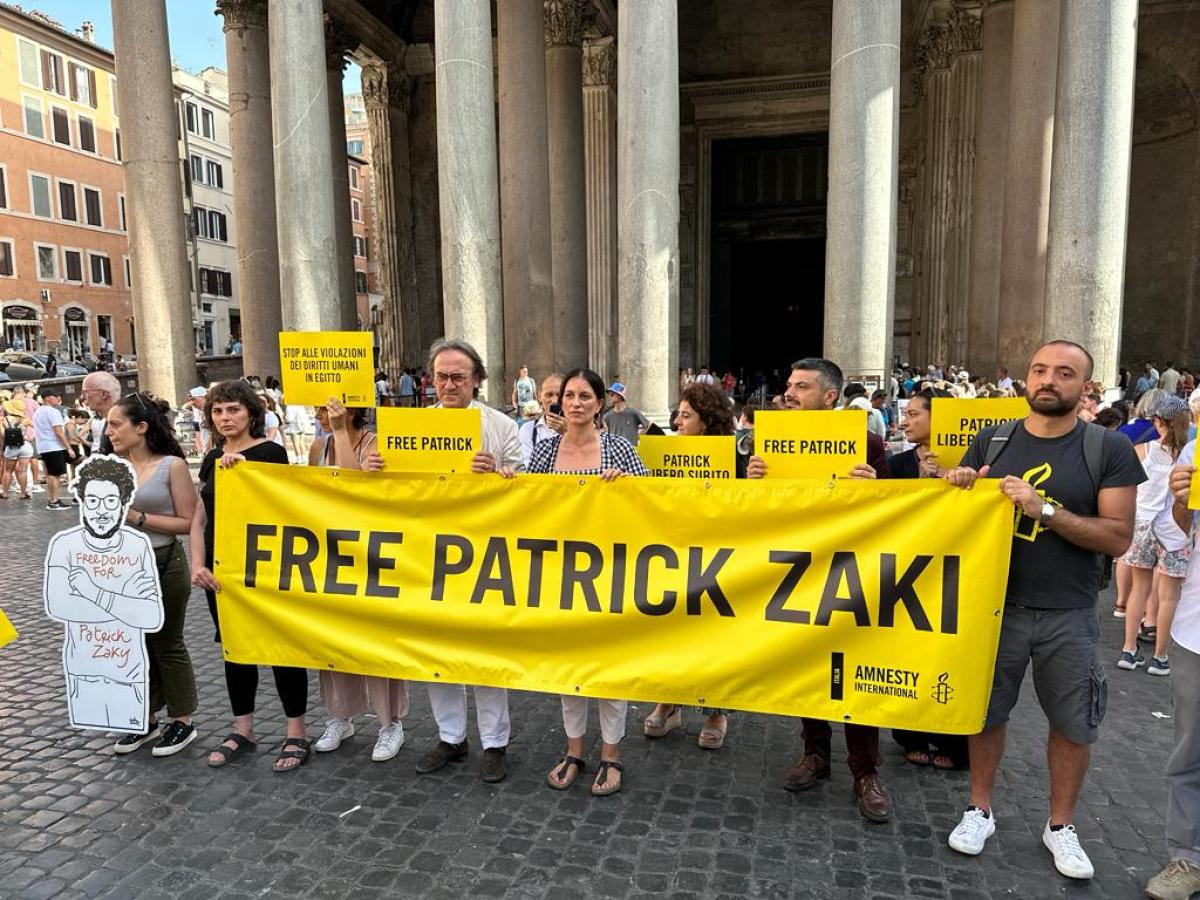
[1146, 453, 1200, 898]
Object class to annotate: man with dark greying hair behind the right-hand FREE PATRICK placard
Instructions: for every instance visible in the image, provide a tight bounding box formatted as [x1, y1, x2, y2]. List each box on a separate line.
[746, 358, 892, 822]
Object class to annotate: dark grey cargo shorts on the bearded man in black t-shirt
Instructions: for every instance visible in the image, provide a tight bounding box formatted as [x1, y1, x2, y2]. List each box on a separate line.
[984, 604, 1109, 744]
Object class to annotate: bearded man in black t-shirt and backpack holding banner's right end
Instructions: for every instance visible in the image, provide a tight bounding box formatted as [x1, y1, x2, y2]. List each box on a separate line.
[946, 341, 1146, 878]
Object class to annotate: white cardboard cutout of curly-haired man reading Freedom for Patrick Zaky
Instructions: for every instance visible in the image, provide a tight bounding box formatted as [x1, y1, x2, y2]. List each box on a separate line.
[42, 456, 163, 733]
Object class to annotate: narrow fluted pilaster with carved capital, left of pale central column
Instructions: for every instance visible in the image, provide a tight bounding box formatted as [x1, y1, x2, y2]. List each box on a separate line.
[583, 37, 619, 378]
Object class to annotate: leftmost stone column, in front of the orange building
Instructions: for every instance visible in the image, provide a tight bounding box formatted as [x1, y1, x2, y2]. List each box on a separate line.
[113, 0, 196, 403]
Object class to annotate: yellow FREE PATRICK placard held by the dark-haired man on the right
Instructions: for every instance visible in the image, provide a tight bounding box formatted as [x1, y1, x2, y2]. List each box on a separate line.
[754, 409, 866, 479]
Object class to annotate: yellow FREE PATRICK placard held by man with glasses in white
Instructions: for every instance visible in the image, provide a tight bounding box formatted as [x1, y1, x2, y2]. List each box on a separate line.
[376, 407, 484, 474]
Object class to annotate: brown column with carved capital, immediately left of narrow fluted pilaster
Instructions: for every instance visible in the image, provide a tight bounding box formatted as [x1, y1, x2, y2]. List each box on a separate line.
[546, 0, 590, 372]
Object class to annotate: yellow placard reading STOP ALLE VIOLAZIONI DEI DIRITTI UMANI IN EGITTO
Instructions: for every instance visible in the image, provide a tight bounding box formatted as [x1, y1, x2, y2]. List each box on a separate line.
[280, 331, 374, 407]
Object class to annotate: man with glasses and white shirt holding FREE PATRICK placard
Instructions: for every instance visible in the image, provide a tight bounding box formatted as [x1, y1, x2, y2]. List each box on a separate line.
[372, 340, 524, 784]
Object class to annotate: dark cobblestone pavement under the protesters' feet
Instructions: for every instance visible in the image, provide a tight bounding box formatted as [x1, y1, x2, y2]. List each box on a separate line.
[0, 494, 1171, 900]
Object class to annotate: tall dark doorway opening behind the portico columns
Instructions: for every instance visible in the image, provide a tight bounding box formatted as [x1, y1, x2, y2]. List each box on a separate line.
[698, 133, 828, 390]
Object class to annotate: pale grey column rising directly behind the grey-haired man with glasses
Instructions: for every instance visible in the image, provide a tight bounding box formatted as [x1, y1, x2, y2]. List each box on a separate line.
[433, 0, 504, 403]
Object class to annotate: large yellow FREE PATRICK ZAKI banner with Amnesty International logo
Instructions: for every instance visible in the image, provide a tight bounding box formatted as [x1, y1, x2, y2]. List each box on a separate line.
[215, 463, 1013, 733]
